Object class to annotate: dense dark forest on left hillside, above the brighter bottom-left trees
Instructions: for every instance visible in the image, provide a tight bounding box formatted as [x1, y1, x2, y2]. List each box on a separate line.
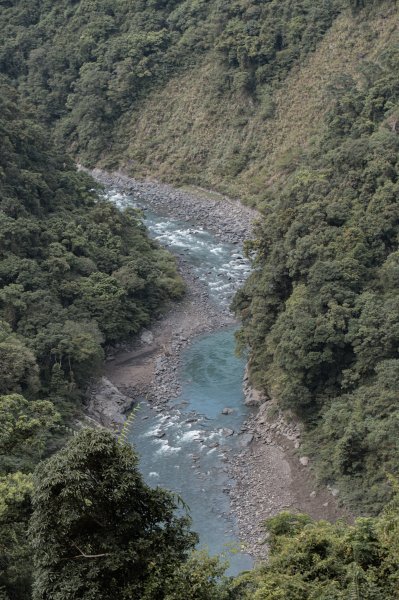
[0, 76, 184, 408]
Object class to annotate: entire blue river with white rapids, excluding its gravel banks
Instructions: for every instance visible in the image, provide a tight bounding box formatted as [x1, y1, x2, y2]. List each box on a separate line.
[108, 188, 253, 575]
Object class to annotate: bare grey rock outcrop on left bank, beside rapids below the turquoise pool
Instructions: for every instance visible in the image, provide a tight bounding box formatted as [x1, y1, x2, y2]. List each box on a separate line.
[87, 377, 134, 429]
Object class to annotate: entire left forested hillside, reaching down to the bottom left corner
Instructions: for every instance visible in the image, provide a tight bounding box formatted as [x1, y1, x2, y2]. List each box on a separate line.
[0, 78, 183, 599]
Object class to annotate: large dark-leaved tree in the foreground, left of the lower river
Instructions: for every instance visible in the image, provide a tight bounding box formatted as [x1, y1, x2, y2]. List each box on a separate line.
[30, 429, 197, 600]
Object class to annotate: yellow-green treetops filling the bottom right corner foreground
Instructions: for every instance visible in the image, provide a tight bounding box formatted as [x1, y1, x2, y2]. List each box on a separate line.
[231, 484, 399, 600]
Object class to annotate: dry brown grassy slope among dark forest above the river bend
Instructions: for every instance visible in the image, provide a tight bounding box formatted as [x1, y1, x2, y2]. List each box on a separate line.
[104, 3, 398, 206]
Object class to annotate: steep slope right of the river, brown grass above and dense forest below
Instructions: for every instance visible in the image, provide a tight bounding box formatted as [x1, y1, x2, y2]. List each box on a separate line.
[120, 3, 399, 513]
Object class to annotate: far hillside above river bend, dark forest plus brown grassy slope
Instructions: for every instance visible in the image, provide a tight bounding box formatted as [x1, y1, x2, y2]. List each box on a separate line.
[0, 0, 398, 203]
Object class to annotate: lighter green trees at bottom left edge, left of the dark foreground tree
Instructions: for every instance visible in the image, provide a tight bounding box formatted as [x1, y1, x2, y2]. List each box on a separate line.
[0, 394, 57, 600]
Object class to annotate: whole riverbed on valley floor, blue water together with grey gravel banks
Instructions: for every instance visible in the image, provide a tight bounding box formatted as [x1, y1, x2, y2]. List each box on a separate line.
[88, 170, 348, 574]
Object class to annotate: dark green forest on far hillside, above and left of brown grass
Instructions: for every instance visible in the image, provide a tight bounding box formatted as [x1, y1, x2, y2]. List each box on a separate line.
[0, 0, 341, 164]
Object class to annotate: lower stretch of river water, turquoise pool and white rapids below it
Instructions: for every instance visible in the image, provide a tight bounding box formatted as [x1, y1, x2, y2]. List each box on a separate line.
[131, 329, 252, 574]
